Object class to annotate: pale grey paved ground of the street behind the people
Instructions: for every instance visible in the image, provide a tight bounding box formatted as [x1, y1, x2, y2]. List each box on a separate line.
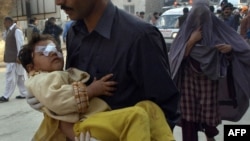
[0, 67, 250, 141]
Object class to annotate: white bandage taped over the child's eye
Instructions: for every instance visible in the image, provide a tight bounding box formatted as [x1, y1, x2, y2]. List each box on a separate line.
[35, 43, 63, 58]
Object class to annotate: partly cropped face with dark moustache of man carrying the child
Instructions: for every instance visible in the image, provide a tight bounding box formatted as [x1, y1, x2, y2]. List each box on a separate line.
[55, 0, 95, 20]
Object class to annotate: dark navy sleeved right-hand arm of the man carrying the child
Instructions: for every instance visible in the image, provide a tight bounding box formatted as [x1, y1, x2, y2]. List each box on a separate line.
[129, 28, 180, 129]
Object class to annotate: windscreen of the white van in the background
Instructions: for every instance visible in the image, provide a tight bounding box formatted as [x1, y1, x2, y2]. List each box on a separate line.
[156, 15, 180, 29]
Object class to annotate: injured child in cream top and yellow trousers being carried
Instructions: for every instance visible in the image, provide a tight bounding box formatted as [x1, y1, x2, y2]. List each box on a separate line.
[18, 35, 174, 141]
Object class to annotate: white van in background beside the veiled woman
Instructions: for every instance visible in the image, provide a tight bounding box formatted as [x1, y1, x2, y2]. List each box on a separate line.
[156, 6, 191, 50]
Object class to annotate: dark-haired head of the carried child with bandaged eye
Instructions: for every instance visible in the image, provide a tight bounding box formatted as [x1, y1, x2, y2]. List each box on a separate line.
[18, 35, 64, 72]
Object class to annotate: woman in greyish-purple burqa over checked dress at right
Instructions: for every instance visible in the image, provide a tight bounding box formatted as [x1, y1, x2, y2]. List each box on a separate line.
[169, 0, 250, 141]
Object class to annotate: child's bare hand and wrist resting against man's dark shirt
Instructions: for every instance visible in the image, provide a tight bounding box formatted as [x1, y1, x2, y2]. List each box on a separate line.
[87, 74, 117, 98]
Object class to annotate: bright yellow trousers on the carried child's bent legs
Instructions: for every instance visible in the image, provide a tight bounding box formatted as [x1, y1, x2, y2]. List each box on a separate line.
[74, 101, 174, 141]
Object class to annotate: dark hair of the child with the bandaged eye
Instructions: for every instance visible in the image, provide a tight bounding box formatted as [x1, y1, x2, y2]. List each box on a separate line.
[18, 34, 61, 72]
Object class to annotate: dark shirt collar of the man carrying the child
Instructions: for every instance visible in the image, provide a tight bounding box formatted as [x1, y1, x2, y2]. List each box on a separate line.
[73, 1, 116, 39]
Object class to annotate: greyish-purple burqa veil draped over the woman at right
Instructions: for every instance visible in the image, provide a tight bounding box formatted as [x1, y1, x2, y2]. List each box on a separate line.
[169, 0, 250, 121]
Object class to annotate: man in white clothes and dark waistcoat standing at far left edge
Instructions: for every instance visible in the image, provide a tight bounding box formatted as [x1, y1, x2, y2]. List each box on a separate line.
[0, 17, 27, 103]
